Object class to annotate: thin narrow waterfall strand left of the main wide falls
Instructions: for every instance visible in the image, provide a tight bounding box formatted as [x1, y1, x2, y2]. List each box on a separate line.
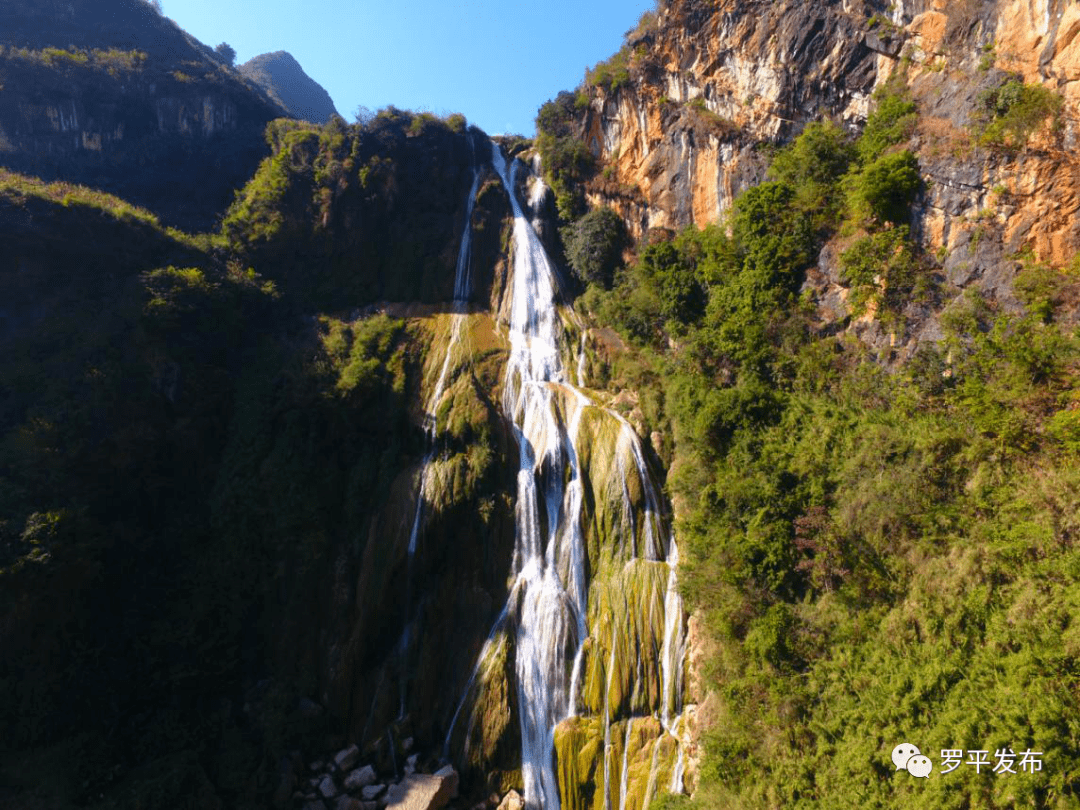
[399, 156, 481, 718]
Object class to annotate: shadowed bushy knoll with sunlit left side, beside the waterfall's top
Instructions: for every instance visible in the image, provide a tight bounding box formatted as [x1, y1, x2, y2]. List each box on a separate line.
[221, 107, 481, 308]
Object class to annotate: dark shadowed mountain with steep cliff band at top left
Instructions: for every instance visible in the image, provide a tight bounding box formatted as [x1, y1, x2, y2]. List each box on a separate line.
[0, 0, 285, 228]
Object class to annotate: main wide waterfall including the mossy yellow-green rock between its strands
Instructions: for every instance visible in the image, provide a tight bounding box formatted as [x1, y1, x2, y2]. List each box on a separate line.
[446, 143, 685, 810]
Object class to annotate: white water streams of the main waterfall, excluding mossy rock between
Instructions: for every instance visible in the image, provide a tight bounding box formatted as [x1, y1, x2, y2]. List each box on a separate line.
[442, 143, 685, 810]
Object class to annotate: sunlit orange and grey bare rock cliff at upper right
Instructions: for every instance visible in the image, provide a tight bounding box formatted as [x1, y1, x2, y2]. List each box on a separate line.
[578, 0, 1080, 353]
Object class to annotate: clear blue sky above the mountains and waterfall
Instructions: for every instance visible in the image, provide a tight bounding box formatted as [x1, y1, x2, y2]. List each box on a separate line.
[162, 0, 654, 135]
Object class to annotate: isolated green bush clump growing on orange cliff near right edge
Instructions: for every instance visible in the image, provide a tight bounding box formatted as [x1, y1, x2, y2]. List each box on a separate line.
[974, 79, 1064, 150]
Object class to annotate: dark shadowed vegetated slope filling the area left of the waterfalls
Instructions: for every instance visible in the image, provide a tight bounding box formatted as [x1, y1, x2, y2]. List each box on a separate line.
[0, 103, 513, 808]
